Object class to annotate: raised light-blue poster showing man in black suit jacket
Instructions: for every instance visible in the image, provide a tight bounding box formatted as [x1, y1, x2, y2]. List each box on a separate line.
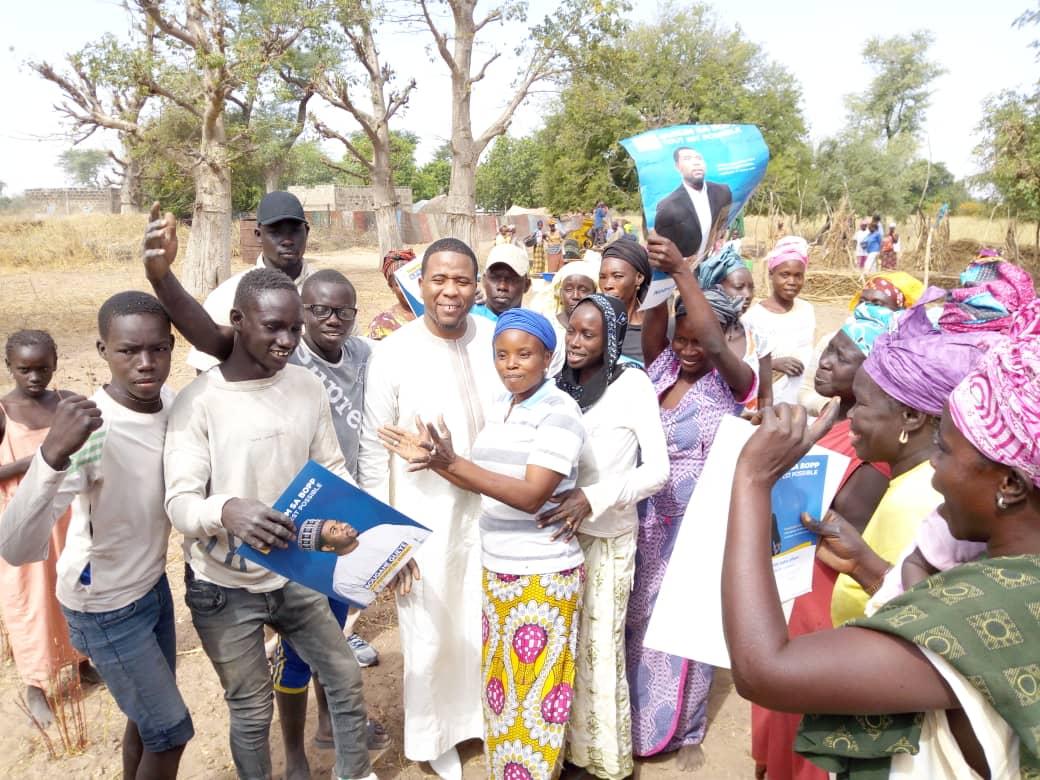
[621, 125, 770, 309]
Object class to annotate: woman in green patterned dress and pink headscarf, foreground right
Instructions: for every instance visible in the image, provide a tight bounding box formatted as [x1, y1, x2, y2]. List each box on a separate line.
[723, 305, 1040, 778]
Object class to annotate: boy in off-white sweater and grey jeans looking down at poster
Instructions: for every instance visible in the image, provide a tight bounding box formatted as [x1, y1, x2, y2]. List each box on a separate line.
[164, 268, 374, 780]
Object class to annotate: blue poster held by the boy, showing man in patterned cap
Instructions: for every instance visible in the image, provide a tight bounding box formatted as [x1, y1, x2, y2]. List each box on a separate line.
[238, 461, 431, 606]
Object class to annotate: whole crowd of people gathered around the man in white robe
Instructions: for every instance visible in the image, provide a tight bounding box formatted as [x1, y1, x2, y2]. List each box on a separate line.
[0, 192, 1040, 780]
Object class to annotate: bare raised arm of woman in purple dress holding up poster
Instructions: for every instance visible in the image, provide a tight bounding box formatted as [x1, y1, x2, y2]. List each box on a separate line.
[648, 233, 755, 399]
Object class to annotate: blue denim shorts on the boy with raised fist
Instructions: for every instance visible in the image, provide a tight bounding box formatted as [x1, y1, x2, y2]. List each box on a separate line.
[61, 574, 194, 753]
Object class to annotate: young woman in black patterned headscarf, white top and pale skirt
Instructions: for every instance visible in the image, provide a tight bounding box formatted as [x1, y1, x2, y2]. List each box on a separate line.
[539, 294, 669, 780]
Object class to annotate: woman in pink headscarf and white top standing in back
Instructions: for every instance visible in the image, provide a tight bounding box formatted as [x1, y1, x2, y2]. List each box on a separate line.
[744, 236, 816, 404]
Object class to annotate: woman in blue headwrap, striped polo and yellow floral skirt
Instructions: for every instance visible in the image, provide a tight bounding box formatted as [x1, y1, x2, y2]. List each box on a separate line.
[380, 309, 586, 778]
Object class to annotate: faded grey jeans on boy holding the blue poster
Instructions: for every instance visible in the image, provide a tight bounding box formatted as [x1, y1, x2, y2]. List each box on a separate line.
[184, 570, 372, 780]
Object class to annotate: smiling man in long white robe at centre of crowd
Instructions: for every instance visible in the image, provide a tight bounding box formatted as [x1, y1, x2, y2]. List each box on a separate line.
[358, 238, 501, 779]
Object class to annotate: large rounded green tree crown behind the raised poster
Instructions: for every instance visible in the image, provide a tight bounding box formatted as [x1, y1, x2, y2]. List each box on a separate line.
[537, 3, 806, 210]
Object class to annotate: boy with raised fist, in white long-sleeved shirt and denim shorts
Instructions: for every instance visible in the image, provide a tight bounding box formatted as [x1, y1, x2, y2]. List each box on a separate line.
[0, 292, 194, 780]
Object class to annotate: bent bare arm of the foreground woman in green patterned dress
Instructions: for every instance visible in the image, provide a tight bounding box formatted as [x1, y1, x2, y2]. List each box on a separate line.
[722, 404, 960, 714]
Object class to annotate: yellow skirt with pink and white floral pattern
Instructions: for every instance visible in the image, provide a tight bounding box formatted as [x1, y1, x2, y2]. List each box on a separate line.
[482, 566, 586, 780]
